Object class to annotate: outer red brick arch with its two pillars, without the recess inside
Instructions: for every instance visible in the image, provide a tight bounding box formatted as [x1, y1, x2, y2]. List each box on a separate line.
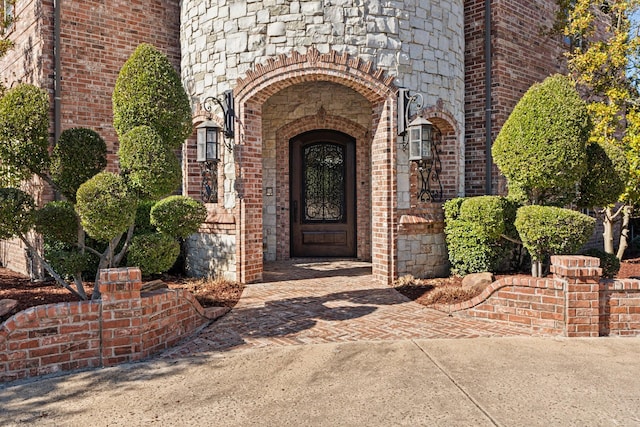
[234, 48, 397, 283]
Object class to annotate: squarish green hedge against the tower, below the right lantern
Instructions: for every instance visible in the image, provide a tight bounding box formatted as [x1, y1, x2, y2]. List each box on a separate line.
[444, 196, 515, 275]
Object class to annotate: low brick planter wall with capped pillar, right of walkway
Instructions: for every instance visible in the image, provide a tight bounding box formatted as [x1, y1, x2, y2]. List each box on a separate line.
[435, 256, 640, 337]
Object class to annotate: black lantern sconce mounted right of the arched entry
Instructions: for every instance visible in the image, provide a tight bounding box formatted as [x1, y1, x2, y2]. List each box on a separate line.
[398, 88, 443, 202]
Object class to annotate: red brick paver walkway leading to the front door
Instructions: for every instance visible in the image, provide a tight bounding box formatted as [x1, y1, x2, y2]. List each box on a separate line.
[164, 260, 531, 357]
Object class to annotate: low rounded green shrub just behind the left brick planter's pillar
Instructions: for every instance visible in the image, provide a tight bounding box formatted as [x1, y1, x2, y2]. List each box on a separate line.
[127, 233, 180, 275]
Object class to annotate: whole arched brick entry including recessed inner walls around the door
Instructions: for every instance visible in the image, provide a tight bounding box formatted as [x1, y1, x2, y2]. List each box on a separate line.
[234, 50, 397, 282]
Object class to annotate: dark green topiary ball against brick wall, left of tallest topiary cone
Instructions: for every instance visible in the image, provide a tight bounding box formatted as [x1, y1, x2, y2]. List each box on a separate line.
[51, 128, 107, 202]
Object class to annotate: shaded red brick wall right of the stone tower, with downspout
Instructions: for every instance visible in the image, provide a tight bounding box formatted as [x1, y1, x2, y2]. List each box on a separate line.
[465, 0, 564, 196]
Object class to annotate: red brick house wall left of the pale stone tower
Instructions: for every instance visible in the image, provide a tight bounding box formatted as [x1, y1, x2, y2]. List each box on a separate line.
[0, 0, 180, 276]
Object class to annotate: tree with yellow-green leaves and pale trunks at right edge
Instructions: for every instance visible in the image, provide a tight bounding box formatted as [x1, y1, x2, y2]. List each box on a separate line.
[556, 0, 640, 259]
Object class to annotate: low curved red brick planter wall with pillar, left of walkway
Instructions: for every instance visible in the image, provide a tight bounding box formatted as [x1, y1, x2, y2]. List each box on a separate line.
[0, 268, 215, 381]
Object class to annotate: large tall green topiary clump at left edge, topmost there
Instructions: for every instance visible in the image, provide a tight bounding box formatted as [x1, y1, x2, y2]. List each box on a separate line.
[0, 84, 49, 186]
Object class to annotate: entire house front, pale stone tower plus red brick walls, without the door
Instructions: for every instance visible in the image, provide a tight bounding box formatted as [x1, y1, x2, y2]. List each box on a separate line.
[0, 0, 580, 282]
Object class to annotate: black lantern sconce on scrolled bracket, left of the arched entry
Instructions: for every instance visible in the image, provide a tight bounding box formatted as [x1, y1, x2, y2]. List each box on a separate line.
[196, 90, 235, 203]
